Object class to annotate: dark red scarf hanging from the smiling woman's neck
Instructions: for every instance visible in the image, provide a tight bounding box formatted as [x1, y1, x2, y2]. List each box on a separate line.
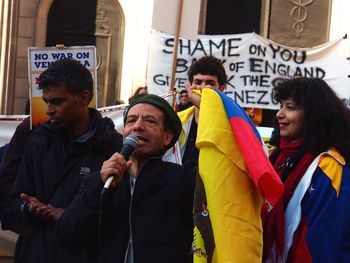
[262, 139, 315, 262]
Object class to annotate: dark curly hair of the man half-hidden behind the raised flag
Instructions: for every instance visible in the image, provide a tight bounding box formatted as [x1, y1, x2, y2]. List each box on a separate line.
[187, 56, 227, 86]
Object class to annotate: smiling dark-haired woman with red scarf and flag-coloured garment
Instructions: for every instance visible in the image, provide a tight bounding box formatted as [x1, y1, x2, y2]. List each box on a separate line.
[262, 78, 350, 262]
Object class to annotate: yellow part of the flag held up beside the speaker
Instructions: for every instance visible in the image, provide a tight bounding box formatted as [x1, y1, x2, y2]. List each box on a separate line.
[196, 89, 263, 263]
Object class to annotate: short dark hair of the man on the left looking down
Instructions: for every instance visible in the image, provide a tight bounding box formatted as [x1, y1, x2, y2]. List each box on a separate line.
[39, 59, 94, 100]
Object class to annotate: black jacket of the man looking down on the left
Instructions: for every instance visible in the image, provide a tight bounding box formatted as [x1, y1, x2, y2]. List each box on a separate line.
[13, 109, 122, 263]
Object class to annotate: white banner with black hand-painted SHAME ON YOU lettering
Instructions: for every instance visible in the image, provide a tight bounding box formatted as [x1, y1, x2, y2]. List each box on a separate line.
[147, 32, 350, 109]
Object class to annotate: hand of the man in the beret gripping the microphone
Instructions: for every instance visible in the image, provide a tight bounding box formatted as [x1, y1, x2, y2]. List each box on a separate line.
[101, 153, 131, 188]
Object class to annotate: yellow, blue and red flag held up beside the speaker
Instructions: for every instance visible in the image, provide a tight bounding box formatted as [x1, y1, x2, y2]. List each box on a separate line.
[195, 89, 283, 263]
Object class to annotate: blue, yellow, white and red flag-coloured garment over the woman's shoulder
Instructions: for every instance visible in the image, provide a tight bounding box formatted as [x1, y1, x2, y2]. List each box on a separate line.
[282, 149, 350, 262]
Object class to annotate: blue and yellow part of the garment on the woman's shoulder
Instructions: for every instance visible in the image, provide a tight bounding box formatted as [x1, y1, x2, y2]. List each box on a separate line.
[302, 157, 350, 262]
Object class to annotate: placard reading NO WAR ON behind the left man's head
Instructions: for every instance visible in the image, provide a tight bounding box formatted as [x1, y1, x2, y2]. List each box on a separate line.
[28, 46, 97, 128]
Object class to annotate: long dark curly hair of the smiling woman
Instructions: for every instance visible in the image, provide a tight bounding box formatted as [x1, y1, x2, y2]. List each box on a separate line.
[272, 78, 350, 163]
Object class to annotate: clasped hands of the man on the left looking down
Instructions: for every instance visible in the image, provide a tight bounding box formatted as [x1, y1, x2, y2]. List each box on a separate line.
[21, 193, 64, 221]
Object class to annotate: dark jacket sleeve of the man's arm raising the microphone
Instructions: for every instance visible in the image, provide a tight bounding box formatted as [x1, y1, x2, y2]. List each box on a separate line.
[56, 172, 103, 253]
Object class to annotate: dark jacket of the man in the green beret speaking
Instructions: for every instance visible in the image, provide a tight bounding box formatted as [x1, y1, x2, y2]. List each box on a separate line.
[57, 158, 194, 263]
